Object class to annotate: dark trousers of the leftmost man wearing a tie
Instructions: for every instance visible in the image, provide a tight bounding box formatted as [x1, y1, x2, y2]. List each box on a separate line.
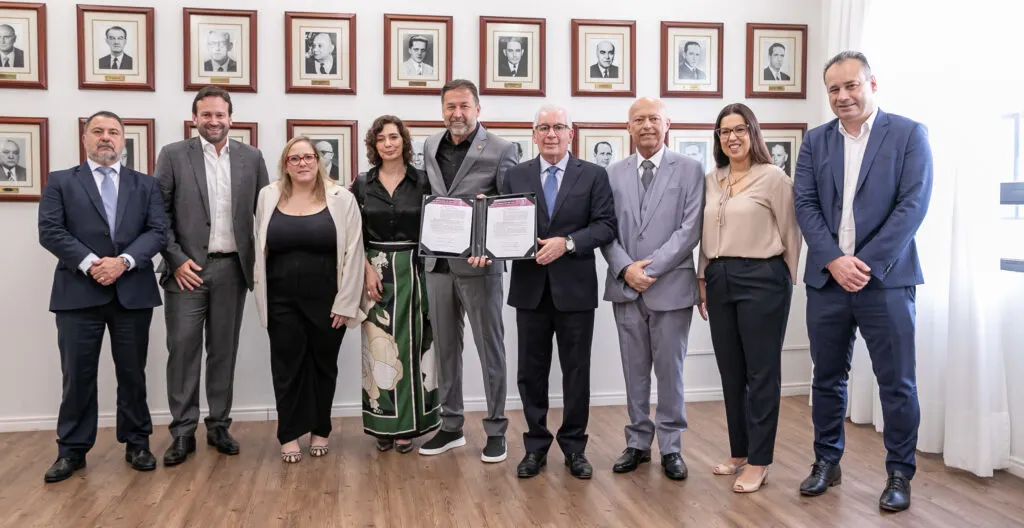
[56, 299, 153, 458]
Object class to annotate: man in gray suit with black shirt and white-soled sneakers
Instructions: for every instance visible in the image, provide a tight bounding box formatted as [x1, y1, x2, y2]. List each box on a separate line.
[420, 79, 516, 463]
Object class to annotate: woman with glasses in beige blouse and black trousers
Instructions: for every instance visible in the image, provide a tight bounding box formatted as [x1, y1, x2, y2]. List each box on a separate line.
[697, 103, 801, 493]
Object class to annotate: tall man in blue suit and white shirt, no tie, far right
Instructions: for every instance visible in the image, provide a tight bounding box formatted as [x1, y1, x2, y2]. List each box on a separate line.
[794, 51, 932, 512]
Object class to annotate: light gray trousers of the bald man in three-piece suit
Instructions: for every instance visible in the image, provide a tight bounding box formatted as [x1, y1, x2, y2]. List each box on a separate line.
[613, 296, 693, 455]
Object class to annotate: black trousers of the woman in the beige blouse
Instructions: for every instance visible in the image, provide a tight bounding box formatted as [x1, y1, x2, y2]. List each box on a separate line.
[705, 257, 793, 466]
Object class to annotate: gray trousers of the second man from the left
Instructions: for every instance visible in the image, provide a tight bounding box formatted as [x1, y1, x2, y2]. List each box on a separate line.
[164, 257, 247, 437]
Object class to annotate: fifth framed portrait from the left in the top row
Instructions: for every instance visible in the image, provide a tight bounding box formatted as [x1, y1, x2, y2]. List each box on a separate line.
[384, 13, 452, 95]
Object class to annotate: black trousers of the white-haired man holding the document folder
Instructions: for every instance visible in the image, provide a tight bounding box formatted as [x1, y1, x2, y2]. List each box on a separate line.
[516, 284, 594, 454]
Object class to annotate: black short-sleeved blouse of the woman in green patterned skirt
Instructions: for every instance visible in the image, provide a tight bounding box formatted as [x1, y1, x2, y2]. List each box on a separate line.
[352, 165, 430, 243]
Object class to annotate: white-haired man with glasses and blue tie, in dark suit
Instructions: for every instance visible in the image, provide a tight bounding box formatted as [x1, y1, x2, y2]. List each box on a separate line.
[502, 105, 616, 479]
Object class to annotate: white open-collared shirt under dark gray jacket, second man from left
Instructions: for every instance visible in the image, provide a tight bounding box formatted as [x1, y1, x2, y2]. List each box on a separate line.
[199, 136, 239, 253]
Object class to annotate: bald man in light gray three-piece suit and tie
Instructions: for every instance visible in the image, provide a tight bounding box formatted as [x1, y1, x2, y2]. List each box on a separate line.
[601, 97, 705, 480]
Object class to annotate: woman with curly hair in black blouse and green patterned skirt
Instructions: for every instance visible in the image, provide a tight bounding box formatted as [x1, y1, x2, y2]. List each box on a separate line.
[352, 116, 440, 453]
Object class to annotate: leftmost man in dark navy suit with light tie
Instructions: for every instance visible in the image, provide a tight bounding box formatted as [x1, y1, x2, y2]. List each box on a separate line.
[39, 112, 167, 482]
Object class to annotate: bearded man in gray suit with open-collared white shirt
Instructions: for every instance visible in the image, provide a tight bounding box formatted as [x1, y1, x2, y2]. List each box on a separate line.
[155, 86, 268, 466]
